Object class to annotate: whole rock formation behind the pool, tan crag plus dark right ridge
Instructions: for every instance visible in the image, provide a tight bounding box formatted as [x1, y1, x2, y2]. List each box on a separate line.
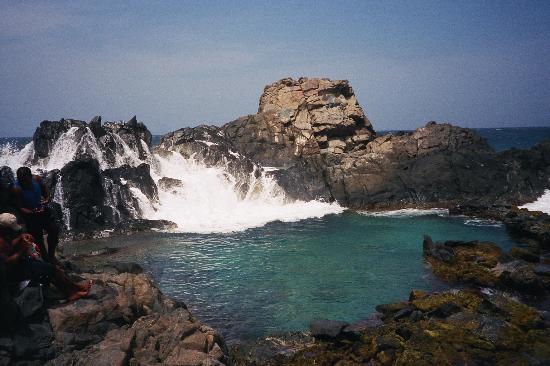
[171, 78, 550, 208]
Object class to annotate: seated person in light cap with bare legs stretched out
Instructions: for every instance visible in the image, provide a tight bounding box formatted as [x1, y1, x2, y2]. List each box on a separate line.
[0, 213, 92, 301]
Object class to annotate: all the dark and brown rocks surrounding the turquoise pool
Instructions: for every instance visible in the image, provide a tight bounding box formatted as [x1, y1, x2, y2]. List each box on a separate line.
[0, 78, 550, 365]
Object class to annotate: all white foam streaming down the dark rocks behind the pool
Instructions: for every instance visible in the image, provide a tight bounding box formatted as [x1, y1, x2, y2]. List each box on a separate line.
[0, 127, 344, 233]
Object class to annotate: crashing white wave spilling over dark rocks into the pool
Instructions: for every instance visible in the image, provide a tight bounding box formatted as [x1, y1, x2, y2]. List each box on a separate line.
[0, 121, 343, 233]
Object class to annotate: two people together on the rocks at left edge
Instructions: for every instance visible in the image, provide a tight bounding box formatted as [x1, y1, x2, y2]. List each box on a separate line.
[0, 167, 91, 301]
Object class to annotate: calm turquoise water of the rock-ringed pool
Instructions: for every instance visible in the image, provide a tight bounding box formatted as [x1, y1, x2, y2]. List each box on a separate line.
[69, 210, 514, 342]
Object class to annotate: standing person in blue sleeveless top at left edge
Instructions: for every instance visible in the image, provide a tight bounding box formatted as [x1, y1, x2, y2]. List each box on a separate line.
[12, 167, 59, 262]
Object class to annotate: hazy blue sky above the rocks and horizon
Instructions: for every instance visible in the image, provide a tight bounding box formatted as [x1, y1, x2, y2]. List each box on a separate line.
[0, 0, 550, 136]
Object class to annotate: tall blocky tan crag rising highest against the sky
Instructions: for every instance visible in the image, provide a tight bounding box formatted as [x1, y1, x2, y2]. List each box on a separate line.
[222, 78, 375, 166]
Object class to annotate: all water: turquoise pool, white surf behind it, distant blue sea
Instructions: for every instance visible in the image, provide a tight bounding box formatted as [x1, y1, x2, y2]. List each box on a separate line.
[0, 127, 550, 344]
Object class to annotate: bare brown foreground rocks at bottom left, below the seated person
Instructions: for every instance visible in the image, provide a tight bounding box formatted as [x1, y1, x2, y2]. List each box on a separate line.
[0, 266, 228, 365]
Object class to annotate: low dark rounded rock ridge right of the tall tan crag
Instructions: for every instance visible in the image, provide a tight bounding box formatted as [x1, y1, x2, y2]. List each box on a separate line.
[326, 122, 550, 208]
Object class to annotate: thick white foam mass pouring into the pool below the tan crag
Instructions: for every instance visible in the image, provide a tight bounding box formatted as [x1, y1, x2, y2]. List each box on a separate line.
[145, 153, 343, 233]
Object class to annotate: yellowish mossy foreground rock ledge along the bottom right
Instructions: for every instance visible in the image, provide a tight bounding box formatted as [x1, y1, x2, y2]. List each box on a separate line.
[236, 290, 550, 366]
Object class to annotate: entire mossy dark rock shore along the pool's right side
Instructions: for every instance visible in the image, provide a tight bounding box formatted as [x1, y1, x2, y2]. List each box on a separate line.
[233, 206, 550, 366]
